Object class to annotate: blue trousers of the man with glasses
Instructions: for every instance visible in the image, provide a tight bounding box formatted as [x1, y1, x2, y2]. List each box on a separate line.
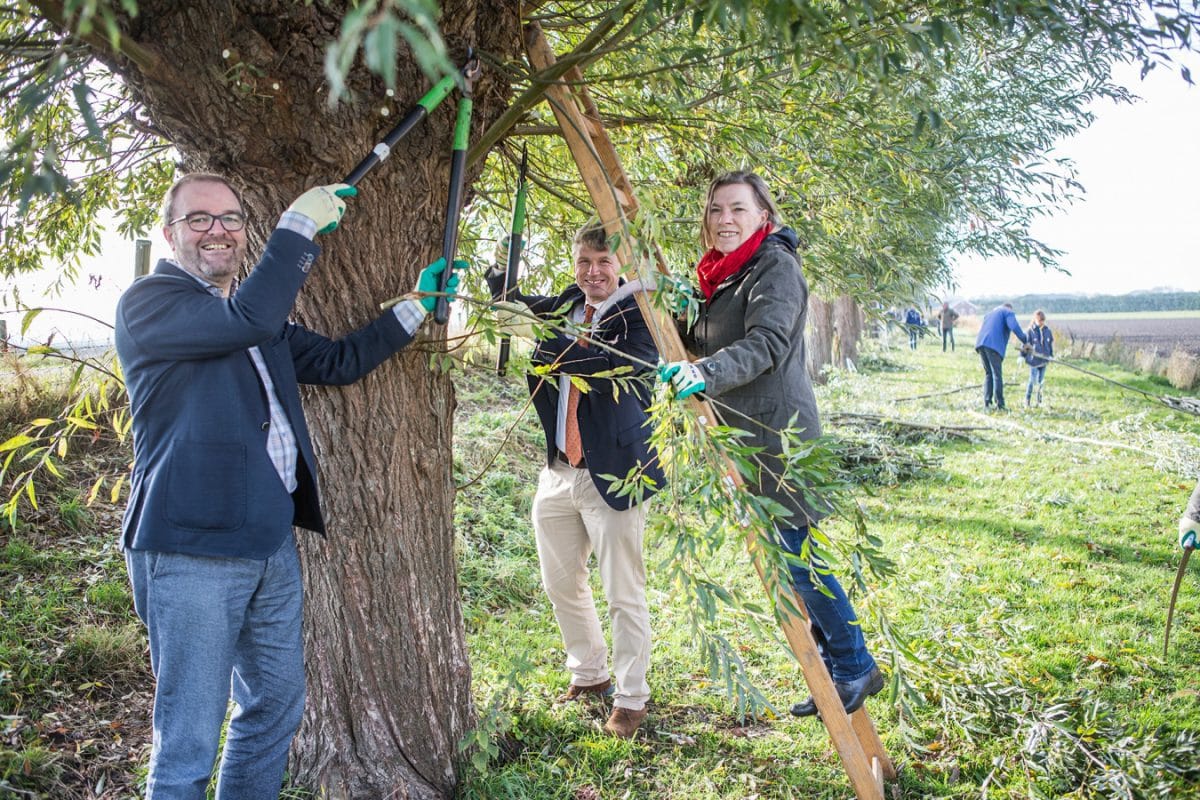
[125, 536, 305, 800]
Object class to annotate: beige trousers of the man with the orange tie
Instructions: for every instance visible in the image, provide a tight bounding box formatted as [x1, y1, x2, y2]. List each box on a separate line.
[533, 461, 650, 710]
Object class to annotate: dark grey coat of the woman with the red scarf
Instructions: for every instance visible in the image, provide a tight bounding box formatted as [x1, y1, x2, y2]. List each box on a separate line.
[680, 228, 828, 528]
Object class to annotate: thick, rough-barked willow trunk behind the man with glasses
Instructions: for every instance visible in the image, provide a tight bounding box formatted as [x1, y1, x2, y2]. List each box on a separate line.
[57, 0, 521, 798]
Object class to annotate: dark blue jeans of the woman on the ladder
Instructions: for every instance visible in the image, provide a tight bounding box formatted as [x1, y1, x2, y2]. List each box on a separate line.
[779, 525, 875, 684]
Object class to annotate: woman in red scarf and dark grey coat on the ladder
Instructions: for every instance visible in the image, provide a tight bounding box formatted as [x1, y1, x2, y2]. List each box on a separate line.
[660, 172, 883, 716]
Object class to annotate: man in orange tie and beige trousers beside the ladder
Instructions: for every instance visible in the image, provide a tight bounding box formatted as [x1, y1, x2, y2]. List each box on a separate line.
[487, 225, 665, 739]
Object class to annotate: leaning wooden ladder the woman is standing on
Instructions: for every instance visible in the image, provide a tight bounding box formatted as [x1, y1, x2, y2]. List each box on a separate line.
[526, 23, 896, 800]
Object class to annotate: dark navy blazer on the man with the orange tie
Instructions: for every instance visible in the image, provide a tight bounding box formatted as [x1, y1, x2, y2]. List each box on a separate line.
[487, 273, 666, 511]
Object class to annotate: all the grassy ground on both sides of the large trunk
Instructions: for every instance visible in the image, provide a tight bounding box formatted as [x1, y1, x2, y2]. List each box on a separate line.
[0, 344, 1200, 800]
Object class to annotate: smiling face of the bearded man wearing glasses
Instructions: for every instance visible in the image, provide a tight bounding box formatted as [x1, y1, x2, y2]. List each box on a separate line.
[162, 181, 246, 295]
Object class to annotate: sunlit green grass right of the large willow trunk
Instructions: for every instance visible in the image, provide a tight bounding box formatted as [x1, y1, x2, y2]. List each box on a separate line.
[460, 345, 1200, 799]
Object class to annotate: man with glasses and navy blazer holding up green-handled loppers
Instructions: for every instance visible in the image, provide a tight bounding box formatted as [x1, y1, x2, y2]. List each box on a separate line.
[115, 174, 466, 800]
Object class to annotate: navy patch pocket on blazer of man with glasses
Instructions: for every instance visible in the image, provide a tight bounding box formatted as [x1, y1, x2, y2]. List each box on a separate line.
[166, 441, 246, 531]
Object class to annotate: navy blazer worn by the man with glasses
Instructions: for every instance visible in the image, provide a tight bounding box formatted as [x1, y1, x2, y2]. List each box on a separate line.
[115, 230, 412, 559]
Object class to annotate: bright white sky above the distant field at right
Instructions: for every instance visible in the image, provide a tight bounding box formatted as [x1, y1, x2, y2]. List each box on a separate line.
[954, 57, 1200, 296]
